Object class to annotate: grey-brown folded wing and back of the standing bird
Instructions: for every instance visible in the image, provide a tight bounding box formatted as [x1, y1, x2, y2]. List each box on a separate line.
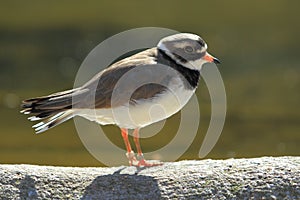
[74, 48, 175, 108]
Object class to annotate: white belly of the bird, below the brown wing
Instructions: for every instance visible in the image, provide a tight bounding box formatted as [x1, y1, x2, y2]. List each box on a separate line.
[77, 84, 195, 129]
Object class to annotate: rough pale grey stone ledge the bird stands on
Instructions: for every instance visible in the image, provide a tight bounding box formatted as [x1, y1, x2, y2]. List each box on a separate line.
[0, 157, 300, 199]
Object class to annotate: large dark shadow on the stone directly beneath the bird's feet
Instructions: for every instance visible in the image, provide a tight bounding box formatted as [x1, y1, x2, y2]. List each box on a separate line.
[81, 167, 161, 200]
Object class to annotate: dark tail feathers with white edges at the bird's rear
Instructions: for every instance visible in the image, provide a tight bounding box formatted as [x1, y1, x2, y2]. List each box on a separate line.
[21, 89, 78, 133]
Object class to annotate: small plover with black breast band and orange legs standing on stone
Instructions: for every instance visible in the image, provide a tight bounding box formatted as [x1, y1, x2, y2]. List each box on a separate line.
[21, 33, 220, 167]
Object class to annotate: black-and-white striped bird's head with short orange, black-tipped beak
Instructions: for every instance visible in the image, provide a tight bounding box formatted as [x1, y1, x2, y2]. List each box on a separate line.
[157, 33, 220, 70]
